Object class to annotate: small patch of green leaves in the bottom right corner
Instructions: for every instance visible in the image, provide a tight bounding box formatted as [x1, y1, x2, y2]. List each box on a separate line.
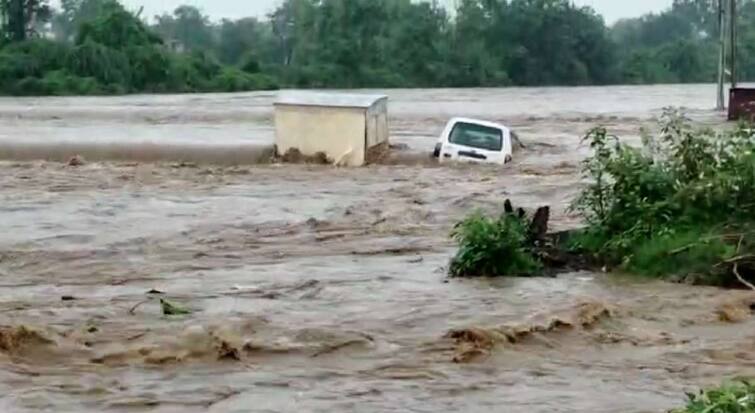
[672, 381, 755, 413]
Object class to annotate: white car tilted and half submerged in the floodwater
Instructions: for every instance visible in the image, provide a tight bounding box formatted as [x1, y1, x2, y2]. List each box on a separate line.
[433, 118, 516, 165]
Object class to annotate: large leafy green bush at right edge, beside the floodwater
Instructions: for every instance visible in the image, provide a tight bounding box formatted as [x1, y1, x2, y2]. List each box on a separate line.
[573, 111, 755, 283]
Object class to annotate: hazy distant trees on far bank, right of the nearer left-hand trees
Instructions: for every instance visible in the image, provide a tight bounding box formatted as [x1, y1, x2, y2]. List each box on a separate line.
[154, 0, 755, 87]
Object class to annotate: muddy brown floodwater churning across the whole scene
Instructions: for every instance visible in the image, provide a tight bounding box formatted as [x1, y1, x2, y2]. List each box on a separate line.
[0, 85, 755, 413]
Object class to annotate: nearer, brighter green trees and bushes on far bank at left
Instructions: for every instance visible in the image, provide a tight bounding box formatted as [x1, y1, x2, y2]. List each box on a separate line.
[0, 0, 277, 95]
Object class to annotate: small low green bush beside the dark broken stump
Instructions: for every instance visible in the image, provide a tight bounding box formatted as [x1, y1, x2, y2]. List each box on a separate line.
[449, 209, 541, 277]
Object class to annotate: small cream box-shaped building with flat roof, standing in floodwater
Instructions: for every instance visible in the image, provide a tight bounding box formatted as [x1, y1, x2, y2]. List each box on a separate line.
[275, 92, 388, 166]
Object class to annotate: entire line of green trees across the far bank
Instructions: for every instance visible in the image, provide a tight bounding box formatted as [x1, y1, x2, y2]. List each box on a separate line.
[0, 0, 755, 94]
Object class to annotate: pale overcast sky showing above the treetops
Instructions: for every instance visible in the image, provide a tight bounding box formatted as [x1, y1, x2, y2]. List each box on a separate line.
[116, 0, 672, 23]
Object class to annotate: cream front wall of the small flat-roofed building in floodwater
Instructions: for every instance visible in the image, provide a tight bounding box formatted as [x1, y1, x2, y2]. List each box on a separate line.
[275, 105, 367, 166]
